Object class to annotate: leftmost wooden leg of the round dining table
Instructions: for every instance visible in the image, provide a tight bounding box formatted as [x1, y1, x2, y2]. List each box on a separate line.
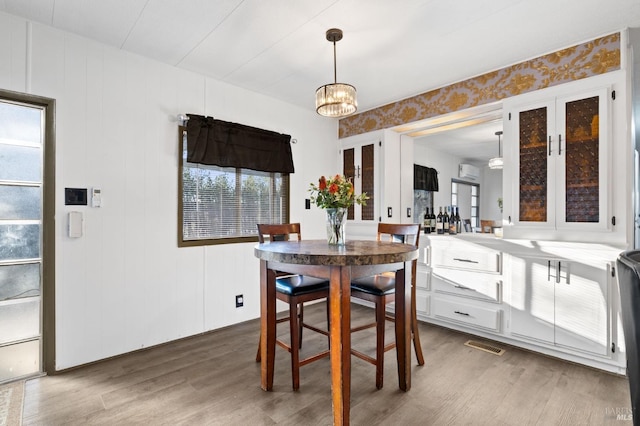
[260, 260, 276, 391]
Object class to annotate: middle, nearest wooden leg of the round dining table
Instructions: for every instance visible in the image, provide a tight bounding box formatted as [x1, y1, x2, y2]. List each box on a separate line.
[329, 266, 351, 426]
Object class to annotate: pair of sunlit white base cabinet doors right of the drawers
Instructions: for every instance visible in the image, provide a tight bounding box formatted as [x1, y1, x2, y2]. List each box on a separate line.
[508, 254, 610, 356]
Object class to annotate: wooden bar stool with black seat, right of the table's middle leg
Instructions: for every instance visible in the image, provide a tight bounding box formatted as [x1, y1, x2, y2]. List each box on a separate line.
[351, 223, 424, 389]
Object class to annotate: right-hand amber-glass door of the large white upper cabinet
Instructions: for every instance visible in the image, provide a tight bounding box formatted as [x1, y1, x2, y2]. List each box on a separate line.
[553, 89, 609, 229]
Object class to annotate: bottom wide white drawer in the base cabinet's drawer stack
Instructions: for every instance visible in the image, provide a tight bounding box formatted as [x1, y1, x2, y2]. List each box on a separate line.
[433, 296, 502, 332]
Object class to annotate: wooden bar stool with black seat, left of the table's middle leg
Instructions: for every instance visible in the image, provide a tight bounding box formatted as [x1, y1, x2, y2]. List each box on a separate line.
[256, 223, 329, 390]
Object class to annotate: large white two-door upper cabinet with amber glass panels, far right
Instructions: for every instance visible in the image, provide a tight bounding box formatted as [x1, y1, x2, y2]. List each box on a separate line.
[504, 87, 612, 230]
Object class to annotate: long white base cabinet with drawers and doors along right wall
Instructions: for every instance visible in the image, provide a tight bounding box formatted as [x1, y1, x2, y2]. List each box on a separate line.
[417, 234, 626, 374]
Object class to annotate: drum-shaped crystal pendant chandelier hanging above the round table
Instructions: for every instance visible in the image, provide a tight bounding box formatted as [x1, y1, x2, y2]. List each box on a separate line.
[316, 28, 358, 118]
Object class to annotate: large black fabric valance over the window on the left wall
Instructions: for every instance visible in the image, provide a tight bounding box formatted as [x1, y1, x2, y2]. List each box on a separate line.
[187, 114, 294, 173]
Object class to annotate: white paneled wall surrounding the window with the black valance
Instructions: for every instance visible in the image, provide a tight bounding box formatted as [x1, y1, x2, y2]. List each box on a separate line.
[0, 13, 338, 369]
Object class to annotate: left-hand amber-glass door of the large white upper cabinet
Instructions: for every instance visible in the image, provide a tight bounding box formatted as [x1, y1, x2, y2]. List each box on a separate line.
[512, 101, 555, 227]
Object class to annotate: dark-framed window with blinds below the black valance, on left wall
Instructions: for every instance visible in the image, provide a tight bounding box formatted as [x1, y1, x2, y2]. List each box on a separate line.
[178, 128, 289, 247]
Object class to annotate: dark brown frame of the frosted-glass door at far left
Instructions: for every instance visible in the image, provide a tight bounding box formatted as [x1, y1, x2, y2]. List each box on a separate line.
[0, 89, 56, 374]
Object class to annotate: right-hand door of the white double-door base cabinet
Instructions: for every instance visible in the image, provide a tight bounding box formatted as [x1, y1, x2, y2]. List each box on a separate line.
[555, 261, 609, 355]
